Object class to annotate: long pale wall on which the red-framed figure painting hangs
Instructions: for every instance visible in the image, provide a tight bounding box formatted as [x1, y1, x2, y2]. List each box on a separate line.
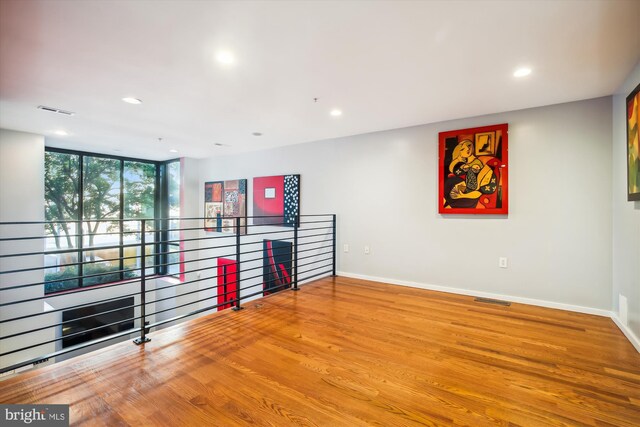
[199, 97, 612, 310]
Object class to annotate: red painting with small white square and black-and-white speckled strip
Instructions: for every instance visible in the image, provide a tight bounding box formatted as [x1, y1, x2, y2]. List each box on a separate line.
[253, 175, 300, 227]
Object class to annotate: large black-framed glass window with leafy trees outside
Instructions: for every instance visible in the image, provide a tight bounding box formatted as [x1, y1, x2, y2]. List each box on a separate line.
[45, 149, 180, 293]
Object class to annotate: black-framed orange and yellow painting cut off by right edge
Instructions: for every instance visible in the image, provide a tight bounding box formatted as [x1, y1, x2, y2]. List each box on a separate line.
[627, 84, 640, 201]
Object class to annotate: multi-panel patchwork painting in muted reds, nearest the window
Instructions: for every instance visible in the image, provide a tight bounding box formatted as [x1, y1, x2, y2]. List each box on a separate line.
[204, 179, 247, 234]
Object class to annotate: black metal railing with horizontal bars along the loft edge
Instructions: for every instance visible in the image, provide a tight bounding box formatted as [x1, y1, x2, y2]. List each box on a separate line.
[0, 214, 336, 374]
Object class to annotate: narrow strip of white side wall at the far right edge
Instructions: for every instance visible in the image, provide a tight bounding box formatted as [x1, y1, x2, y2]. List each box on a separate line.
[612, 63, 640, 342]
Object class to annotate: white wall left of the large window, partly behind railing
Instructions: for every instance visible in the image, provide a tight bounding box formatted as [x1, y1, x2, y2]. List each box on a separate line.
[0, 129, 55, 372]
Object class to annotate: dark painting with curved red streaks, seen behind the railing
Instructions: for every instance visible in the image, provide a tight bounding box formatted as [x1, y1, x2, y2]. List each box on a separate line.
[262, 239, 293, 295]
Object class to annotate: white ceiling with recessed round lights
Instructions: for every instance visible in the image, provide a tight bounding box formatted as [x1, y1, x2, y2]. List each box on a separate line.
[0, 0, 640, 160]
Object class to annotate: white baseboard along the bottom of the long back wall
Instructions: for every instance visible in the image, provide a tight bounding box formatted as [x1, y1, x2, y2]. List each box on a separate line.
[336, 271, 611, 317]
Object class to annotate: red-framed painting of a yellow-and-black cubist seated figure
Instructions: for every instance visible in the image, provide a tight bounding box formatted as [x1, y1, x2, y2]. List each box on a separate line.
[438, 123, 509, 215]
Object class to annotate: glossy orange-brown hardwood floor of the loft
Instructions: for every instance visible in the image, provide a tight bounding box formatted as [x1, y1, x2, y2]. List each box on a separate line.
[0, 277, 640, 426]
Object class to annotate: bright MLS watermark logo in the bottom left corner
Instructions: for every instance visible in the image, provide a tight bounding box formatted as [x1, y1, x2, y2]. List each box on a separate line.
[0, 404, 69, 427]
